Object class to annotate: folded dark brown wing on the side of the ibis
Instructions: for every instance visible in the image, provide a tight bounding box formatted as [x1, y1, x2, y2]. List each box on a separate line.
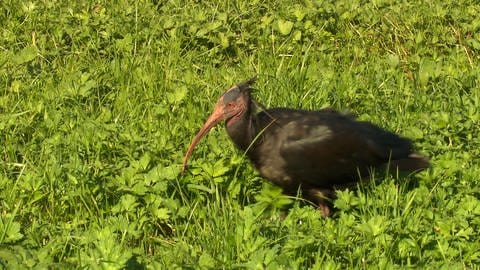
[280, 114, 389, 185]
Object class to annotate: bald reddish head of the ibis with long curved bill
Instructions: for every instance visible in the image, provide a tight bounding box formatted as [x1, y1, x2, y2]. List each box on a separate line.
[182, 77, 256, 174]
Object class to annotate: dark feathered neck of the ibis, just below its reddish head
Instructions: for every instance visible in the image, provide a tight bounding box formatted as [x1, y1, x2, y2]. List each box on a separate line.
[226, 110, 257, 151]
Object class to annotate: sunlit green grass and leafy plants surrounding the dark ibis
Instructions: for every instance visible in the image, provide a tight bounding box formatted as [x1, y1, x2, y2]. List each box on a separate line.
[0, 0, 480, 269]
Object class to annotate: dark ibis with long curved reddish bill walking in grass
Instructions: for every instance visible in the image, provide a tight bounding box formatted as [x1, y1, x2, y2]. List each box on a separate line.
[182, 77, 430, 217]
